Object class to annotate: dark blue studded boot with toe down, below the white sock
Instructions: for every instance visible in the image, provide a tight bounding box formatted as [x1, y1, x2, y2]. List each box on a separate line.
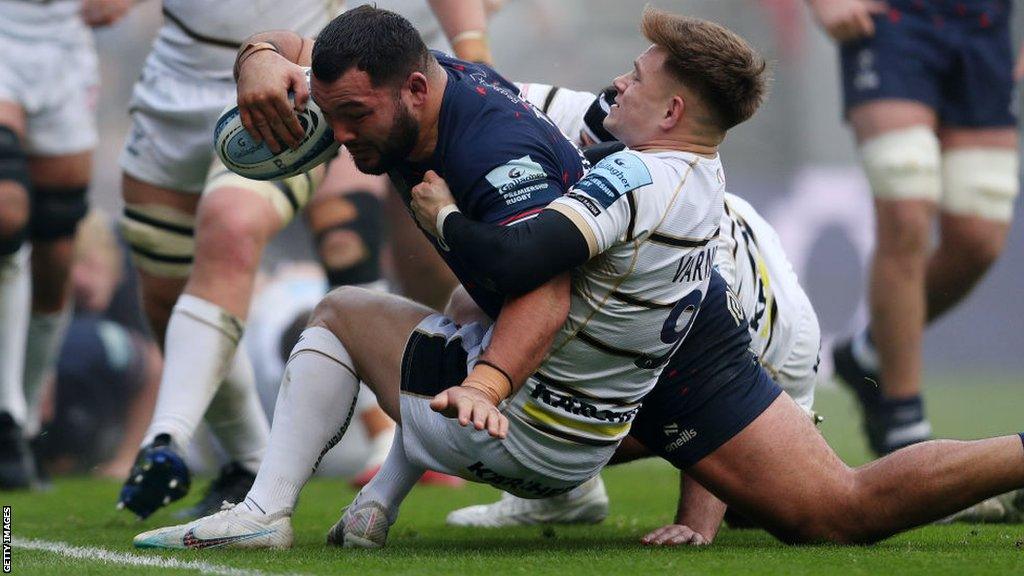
[118, 434, 191, 520]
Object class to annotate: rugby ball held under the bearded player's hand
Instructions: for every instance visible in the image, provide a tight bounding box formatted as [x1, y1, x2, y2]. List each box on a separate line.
[213, 69, 338, 180]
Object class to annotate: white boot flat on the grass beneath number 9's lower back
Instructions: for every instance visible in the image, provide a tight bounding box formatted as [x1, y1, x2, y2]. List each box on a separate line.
[446, 476, 608, 528]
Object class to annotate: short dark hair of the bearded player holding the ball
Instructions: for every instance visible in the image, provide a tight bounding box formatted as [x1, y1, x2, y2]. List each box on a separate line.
[312, 4, 430, 87]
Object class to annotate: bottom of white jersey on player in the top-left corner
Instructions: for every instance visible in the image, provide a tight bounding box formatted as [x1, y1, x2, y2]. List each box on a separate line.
[0, 0, 89, 43]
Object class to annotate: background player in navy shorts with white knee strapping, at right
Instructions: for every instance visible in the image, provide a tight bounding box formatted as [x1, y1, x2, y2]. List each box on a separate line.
[808, 0, 1018, 454]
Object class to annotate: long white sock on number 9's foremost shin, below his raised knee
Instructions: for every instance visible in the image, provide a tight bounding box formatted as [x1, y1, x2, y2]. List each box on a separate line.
[245, 327, 359, 513]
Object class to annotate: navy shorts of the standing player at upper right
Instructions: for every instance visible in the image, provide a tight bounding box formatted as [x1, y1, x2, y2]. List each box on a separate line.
[840, 0, 1016, 127]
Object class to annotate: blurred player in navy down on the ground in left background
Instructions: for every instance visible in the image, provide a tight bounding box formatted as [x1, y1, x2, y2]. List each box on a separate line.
[34, 209, 161, 480]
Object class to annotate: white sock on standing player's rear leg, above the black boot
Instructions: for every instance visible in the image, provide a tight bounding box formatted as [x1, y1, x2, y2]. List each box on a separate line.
[206, 346, 270, 474]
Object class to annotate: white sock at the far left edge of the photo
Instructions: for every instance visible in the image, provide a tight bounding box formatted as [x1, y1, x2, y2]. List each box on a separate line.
[0, 246, 32, 424]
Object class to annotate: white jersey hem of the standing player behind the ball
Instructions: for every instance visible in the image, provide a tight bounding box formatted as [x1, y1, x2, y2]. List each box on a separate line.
[146, 0, 343, 80]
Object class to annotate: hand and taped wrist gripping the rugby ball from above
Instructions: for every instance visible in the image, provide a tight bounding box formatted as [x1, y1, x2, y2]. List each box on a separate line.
[234, 30, 313, 154]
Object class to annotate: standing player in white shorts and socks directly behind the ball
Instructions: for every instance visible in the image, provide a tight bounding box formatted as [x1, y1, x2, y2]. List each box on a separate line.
[119, 0, 484, 518]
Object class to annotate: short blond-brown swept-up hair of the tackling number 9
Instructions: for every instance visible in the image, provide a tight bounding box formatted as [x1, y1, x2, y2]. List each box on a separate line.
[640, 6, 768, 131]
